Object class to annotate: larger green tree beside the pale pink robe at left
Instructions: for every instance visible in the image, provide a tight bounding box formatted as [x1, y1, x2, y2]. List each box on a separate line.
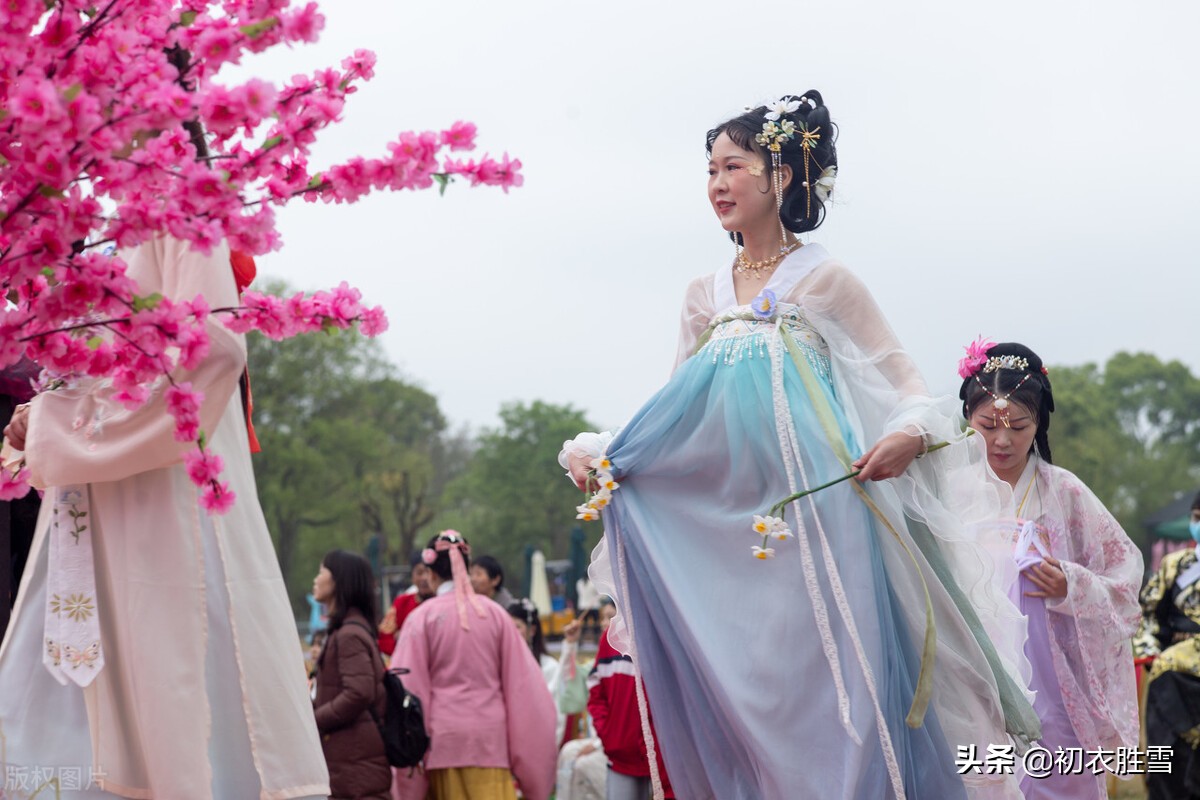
[247, 284, 462, 608]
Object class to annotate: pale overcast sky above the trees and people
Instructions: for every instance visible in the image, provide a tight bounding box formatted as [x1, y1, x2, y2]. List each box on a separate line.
[238, 0, 1200, 427]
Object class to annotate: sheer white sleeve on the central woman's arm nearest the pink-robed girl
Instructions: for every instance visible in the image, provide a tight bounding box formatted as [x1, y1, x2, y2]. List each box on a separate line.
[785, 260, 1037, 750]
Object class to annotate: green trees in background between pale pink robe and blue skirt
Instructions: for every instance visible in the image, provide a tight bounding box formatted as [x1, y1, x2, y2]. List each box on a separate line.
[247, 283, 600, 614]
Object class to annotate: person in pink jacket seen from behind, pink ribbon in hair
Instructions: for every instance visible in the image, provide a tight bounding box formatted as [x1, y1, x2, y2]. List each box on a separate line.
[391, 530, 557, 800]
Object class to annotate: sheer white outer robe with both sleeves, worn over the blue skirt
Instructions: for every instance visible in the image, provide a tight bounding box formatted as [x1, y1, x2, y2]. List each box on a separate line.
[580, 245, 1037, 796]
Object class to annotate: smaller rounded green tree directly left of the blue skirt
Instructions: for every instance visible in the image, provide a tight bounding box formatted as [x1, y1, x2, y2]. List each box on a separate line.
[433, 401, 601, 582]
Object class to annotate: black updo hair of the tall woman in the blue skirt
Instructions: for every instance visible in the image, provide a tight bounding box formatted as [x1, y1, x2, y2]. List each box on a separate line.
[706, 89, 838, 236]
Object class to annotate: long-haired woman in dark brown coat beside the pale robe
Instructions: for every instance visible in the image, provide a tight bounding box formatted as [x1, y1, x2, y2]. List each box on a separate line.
[312, 551, 391, 800]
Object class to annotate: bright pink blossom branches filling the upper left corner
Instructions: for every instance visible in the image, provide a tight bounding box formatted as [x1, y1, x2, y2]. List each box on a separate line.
[0, 0, 523, 513]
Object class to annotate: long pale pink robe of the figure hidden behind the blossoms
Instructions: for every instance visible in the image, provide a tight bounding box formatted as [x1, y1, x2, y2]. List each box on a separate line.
[0, 239, 329, 800]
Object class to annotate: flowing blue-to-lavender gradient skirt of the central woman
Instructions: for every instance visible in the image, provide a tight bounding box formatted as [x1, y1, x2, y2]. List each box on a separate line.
[604, 332, 966, 800]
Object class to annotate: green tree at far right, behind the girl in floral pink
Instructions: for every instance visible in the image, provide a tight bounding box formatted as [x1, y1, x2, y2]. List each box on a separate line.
[1050, 353, 1200, 542]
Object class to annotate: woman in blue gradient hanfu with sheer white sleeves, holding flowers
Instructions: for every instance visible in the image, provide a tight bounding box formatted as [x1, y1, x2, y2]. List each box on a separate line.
[560, 91, 1038, 800]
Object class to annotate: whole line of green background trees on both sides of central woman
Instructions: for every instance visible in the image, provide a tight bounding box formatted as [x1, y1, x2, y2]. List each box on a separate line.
[248, 291, 1200, 613]
